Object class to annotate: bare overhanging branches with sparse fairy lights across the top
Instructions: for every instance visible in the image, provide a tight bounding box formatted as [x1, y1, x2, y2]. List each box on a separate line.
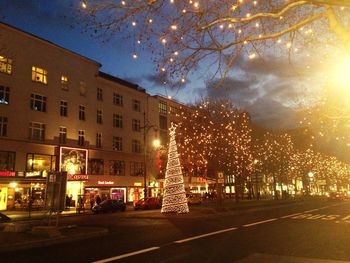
[82, 0, 350, 83]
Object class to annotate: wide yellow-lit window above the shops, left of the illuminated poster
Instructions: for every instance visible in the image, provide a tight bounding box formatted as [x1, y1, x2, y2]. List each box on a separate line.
[26, 153, 56, 175]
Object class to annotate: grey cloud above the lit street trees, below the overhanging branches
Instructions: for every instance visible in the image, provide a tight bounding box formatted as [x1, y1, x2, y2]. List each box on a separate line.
[202, 57, 318, 128]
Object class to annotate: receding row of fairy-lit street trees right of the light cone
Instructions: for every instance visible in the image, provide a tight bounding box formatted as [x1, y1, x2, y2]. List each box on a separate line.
[168, 102, 350, 192]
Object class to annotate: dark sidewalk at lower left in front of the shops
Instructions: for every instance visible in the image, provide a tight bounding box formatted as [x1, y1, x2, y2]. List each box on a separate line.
[0, 209, 108, 253]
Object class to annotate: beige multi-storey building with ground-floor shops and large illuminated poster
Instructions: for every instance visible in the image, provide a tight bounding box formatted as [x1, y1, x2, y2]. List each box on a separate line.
[0, 23, 161, 210]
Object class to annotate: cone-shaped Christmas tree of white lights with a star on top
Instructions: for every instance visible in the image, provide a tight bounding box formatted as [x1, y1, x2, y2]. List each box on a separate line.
[162, 123, 189, 213]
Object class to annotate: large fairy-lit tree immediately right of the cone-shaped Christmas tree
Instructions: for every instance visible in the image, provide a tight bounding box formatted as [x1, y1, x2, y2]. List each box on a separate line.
[179, 99, 251, 202]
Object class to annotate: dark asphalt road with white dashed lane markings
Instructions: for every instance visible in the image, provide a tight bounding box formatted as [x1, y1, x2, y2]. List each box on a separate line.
[0, 200, 350, 263]
